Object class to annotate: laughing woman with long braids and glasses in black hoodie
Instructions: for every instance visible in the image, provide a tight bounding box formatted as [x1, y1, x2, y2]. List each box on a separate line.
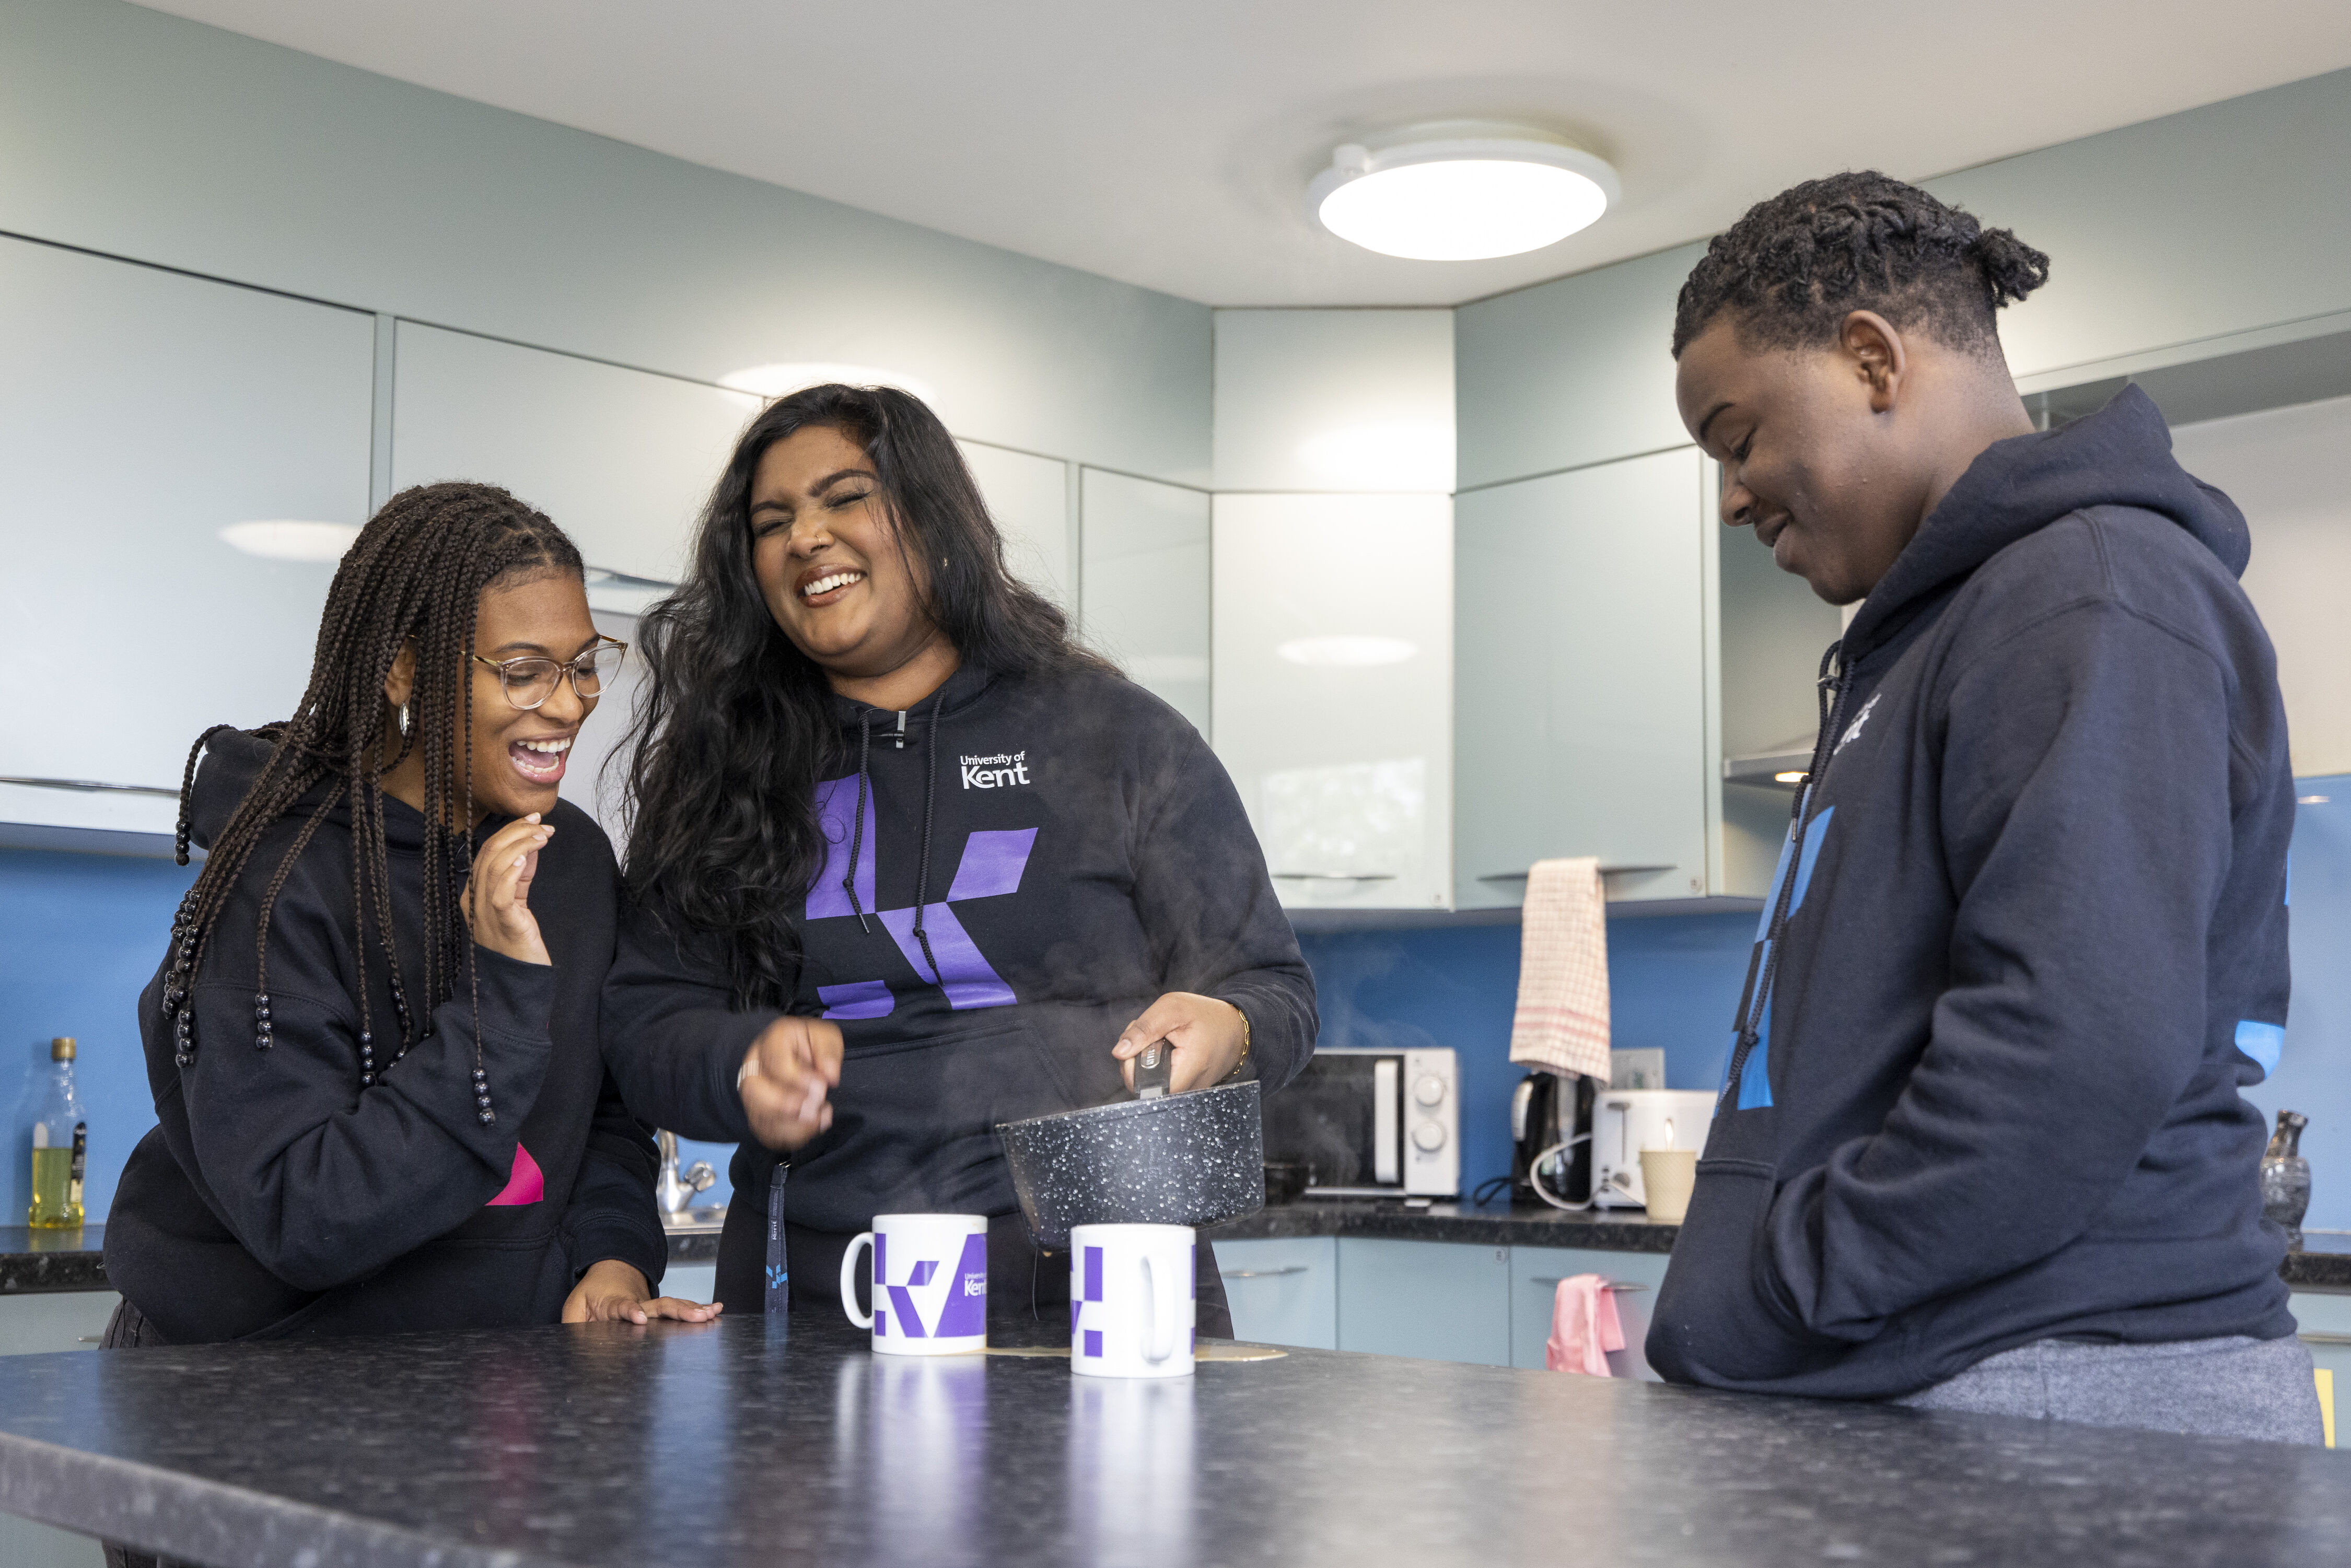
[106, 484, 710, 1344]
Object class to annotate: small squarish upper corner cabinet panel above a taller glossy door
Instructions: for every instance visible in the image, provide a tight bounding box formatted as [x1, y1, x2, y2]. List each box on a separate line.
[1216, 310, 1453, 494]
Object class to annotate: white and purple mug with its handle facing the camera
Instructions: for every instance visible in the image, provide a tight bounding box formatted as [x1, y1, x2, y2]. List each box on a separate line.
[1070, 1225, 1199, 1377]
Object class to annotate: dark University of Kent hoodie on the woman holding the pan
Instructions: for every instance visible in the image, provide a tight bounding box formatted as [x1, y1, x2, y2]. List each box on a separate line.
[604, 663, 1314, 1293]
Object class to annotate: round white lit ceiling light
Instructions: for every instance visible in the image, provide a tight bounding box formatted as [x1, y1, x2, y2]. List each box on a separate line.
[1307, 120, 1622, 261]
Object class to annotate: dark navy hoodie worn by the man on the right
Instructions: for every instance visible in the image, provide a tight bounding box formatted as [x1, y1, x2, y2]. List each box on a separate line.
[1648, 388, 2295, 1399]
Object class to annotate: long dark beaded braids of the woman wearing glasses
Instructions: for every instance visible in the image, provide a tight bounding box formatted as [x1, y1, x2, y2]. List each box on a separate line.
[162, 484, 583, 1126]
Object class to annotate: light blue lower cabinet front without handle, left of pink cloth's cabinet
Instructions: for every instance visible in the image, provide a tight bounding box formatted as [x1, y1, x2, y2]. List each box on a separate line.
[1338, 1236, 1509, 1366]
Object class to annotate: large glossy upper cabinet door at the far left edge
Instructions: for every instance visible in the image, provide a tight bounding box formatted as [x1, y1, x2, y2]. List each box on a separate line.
[0, 240, 374, 832]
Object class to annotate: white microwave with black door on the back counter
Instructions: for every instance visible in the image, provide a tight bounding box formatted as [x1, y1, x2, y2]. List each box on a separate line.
[1265, 1046, 1462, 1197]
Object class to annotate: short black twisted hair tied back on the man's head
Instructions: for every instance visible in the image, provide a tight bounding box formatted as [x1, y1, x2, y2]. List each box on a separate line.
[1674, 172, 2050, 360]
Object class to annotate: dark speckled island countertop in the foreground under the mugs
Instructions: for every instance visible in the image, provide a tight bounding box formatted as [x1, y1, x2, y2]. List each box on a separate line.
[0, 1312, 2351, 1568]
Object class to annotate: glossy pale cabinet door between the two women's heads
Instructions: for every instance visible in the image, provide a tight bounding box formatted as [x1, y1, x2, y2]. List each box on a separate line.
[393, 322, 760, 583]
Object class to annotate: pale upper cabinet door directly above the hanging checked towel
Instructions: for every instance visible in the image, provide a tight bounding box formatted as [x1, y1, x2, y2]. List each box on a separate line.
[1453, 447, 1714, 907]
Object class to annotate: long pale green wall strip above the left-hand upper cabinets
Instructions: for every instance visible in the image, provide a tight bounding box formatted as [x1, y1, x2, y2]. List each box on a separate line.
[0, 0, 1211, 484]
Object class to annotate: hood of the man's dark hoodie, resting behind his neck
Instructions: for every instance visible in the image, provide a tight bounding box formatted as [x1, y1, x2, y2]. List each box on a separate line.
[1843, 385, 2252, 668]
